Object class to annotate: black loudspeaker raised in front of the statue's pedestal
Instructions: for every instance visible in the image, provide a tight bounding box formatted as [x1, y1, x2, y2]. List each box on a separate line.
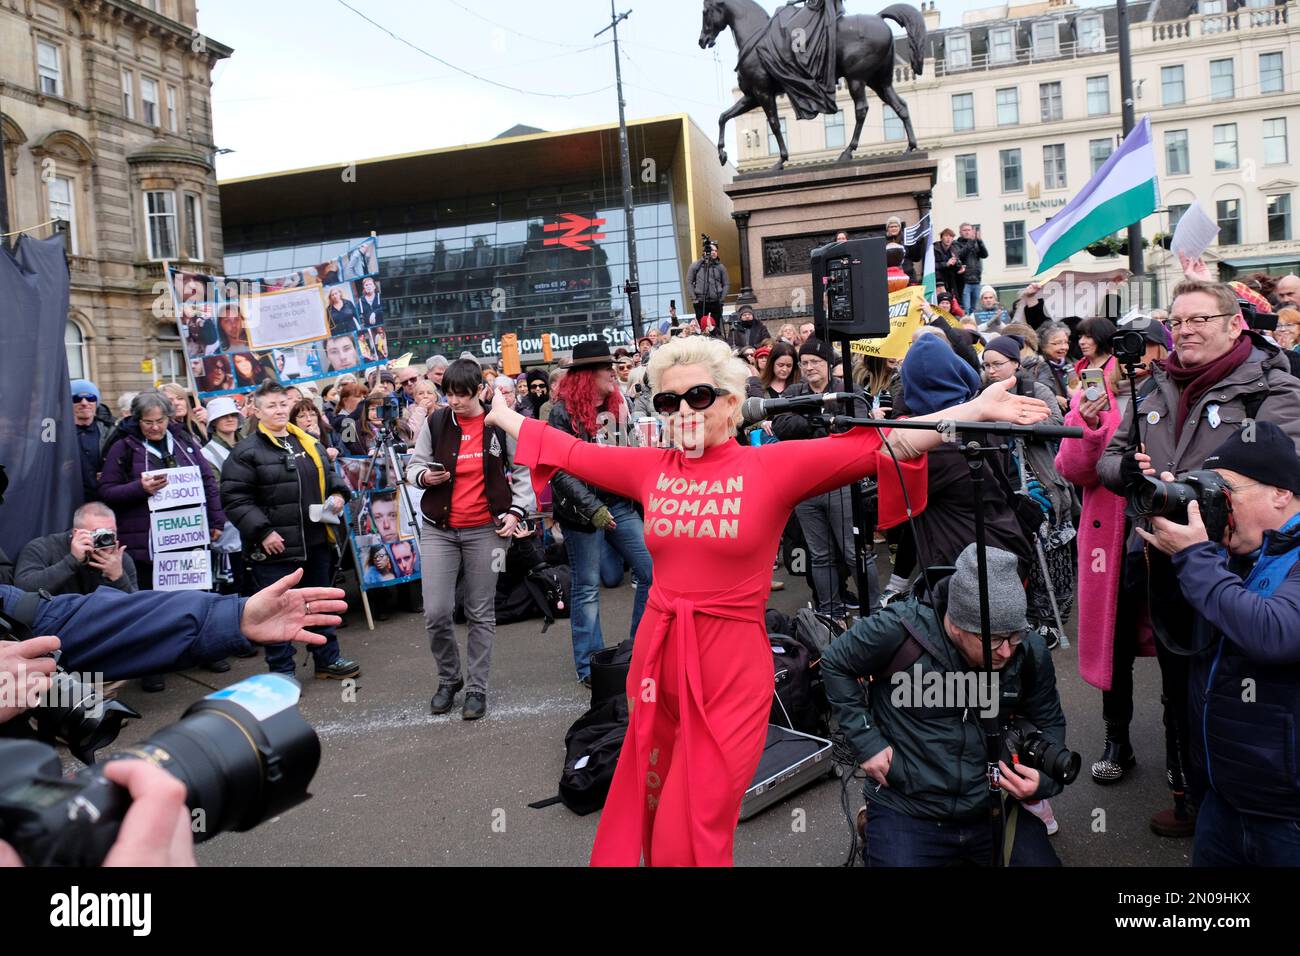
[813, 238, 889, 338]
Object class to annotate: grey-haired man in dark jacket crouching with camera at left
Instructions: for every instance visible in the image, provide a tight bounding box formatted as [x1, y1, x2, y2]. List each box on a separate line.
[14, 501, 139, 594]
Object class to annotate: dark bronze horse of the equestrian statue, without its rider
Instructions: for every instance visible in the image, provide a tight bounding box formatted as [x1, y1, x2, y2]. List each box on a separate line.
[699, 0, 926, 169]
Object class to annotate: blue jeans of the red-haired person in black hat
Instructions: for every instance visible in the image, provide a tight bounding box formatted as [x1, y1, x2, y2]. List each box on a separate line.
[564, 501, 653, 680]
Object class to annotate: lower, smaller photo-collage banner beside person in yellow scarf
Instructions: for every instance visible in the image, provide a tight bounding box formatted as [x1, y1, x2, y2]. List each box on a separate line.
[334, 455, 420, 591]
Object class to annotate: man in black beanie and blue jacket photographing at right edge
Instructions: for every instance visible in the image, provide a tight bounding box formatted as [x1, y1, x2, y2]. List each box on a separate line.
[1138, 421, 1300, 866]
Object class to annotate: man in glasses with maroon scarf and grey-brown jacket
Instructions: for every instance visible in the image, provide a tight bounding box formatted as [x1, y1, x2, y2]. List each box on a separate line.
[1102, 278, 1300, 836]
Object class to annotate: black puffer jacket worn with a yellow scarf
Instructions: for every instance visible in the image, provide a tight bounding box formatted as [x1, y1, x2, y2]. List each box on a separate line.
[221, 429, 352, 561]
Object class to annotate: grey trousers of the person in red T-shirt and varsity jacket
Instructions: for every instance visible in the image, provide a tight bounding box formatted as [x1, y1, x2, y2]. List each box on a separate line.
[420, 522, 510, 693]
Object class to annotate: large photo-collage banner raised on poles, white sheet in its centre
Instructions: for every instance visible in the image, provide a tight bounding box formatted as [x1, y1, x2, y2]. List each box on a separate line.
[168, 235, 389, 401]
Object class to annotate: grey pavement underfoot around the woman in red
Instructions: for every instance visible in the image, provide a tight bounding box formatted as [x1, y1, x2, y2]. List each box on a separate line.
[106, 561, 1191, 866]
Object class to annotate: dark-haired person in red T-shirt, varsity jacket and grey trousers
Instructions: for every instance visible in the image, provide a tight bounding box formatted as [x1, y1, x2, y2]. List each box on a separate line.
[407, 359, 537, 721]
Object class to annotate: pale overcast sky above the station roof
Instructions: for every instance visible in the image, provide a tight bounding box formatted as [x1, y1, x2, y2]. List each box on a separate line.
[199, 0, 1093, 179]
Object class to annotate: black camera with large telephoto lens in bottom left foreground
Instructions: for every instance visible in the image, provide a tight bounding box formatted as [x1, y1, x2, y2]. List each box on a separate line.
[0, 674, 321, 866]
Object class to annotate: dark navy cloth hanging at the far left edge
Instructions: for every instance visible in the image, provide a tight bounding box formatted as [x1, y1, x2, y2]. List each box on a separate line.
[0, 235, 82, 558]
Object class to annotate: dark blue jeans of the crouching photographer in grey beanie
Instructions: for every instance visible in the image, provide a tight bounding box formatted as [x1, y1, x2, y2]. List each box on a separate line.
[862, 800, 1061, 866]
